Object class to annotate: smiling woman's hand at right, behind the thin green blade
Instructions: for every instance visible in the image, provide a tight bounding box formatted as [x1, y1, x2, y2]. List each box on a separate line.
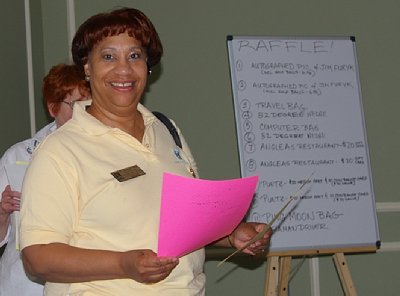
[227, 222, 272, 255]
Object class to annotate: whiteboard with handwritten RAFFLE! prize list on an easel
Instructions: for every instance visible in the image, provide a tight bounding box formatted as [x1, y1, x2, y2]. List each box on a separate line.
[227, 36, 379, 252]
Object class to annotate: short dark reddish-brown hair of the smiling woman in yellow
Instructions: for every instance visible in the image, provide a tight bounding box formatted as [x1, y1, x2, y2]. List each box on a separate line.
[71, 7, 163, 71]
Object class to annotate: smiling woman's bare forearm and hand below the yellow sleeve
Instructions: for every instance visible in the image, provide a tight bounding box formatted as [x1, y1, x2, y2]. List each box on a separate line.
[22, 243, 179, 284]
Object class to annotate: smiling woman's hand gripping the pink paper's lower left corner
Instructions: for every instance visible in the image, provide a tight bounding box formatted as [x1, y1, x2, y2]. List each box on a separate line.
[121, 250, 179, 284]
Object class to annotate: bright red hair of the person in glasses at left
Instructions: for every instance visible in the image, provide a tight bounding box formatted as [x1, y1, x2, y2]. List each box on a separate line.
[42, 64, 90, 114]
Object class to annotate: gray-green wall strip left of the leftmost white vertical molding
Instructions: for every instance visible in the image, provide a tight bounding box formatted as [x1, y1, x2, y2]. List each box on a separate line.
[0, 0, 30, 153]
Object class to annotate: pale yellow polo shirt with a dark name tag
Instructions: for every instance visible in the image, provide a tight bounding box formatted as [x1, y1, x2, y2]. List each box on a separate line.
[20, 101, 205, 296]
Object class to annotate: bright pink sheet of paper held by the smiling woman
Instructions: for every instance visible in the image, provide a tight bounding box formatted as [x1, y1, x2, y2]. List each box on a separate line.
[158, 173, 258, 257]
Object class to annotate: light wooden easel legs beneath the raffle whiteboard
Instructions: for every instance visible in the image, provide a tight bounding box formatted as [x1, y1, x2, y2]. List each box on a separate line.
[264, 253, 357, 296]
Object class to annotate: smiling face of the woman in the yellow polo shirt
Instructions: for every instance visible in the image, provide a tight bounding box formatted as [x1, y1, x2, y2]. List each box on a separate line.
[85, 33, 147, 116]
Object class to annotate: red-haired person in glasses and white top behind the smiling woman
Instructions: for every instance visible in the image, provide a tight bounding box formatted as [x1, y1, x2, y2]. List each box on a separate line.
[0, 64, 90, 296]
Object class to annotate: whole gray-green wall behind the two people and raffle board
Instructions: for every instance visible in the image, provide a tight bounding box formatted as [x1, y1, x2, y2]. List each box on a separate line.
[0, 0, 400, 296]
